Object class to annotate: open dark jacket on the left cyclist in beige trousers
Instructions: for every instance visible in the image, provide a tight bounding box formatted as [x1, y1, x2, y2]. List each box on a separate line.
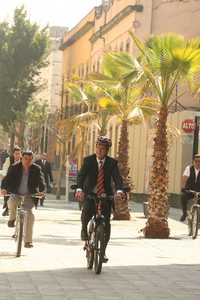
[1, 162, 45, 194]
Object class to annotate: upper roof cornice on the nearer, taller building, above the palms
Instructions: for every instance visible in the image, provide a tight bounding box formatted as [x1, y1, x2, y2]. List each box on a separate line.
[90, 4, 144, 43]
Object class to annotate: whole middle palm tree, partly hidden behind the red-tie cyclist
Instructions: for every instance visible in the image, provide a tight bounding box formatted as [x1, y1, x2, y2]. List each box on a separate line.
[90, 52, 158, 220]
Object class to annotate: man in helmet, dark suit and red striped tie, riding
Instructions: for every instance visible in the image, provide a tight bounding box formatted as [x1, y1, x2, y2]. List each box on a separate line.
[75, 136, 123, 262]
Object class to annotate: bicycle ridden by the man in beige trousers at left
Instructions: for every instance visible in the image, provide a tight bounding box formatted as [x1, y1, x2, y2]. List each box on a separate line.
[12, 194, 43, 257]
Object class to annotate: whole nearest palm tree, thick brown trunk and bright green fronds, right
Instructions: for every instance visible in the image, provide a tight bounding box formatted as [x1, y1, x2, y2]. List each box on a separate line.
[128, 33, 200, 238]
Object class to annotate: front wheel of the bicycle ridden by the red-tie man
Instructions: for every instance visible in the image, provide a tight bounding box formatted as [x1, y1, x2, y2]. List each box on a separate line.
[94, 224, 105, 274]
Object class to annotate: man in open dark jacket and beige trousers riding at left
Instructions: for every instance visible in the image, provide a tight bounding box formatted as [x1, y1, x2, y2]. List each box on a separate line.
[1, 151, 45, 248]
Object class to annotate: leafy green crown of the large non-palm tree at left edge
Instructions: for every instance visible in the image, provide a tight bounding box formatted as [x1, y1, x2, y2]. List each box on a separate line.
[0, 6, 48, 135]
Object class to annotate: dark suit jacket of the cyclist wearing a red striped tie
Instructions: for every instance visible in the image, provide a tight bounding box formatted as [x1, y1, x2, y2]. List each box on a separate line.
[77, 154, 123, 195]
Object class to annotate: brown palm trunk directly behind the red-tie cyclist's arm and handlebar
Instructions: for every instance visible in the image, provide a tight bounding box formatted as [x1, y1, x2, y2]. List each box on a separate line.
[113, 120, 130, 220]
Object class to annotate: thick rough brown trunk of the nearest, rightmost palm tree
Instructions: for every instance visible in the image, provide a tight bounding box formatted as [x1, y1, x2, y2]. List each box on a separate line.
[144, 106, 170, 238]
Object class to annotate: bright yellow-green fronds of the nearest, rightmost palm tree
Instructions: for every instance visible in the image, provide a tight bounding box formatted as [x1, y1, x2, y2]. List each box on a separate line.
[131, 33, 200, 105]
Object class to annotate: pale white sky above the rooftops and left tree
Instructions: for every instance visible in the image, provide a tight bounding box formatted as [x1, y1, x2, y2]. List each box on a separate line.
[0, 0, 102, 29]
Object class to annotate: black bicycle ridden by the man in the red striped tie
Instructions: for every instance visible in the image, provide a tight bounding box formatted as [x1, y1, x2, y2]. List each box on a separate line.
[84, 194, 113, 274]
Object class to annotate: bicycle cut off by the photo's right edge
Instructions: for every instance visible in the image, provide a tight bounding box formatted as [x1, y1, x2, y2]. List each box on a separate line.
[185, 190, 200, 239]
